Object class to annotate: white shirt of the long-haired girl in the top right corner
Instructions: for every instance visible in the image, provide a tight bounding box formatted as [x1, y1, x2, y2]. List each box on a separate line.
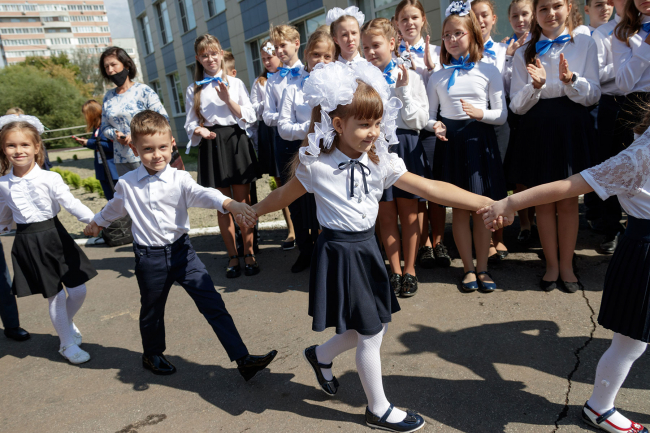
[612, 15, 650, 95]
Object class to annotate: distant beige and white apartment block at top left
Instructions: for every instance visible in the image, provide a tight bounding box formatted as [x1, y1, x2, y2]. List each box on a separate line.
[0, 0, 111, 67]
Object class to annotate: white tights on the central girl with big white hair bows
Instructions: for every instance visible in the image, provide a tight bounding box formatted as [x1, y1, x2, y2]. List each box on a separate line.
[316, 324, 406, 422]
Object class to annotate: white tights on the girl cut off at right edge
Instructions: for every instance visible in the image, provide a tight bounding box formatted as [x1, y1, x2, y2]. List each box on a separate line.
[587, 334, 648, 429]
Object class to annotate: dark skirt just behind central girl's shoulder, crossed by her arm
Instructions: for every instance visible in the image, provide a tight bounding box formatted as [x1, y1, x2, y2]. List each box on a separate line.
[381, 129, 428, 201]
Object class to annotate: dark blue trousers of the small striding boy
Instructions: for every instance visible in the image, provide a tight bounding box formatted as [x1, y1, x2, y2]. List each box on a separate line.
[133, 234, 248, 361]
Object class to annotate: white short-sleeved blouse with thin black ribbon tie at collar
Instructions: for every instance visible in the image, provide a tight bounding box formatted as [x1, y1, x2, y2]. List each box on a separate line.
[296, 147, 407, 232]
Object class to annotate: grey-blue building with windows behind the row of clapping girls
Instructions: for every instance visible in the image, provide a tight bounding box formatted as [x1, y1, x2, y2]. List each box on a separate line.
[126, 0, 440, 144]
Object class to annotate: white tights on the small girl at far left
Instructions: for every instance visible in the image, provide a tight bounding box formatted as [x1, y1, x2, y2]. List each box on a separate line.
[47, 284, 86, 356]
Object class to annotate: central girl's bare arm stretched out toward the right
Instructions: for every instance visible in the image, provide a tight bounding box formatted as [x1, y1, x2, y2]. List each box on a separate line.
[395, 172, 493, 211]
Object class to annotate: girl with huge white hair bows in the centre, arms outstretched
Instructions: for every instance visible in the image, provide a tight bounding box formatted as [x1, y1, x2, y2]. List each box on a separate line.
[248, 62, 492, 432]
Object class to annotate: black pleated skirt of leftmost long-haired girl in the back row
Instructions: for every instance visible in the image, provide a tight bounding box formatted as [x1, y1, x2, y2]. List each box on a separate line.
[197, 125, 259, 188]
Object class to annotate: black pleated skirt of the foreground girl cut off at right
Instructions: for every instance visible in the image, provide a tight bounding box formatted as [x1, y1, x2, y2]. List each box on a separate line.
[598, 215, 650, 343]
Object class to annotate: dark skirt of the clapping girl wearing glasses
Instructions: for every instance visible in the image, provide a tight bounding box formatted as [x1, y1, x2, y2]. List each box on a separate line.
[433, 117, 508, 200]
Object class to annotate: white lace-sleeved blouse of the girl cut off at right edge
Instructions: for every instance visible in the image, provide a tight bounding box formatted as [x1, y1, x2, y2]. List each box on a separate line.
[580, 126, 650, 219]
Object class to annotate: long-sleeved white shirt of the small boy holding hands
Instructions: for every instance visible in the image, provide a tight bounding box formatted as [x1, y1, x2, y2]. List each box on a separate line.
[94, 165, 228, 247]
